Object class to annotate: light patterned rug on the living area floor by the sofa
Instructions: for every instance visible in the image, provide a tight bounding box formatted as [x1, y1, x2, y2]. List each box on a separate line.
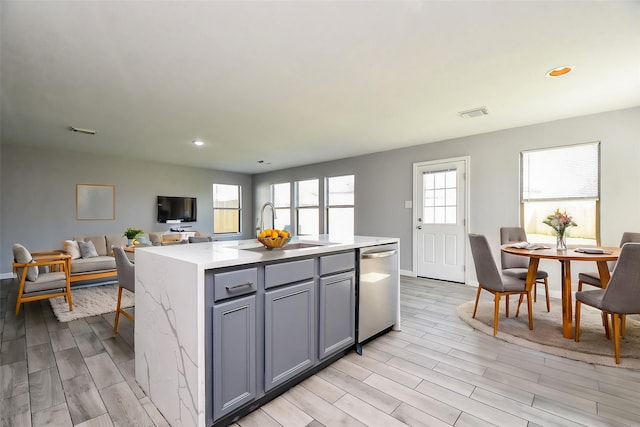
[49, 285, 135, 322]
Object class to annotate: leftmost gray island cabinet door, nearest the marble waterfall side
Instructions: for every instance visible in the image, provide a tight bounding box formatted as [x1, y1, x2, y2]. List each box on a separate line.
[213, 295, 256, 419]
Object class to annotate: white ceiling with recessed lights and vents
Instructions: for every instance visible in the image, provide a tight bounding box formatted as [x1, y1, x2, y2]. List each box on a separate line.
[0, 0, 640, 173]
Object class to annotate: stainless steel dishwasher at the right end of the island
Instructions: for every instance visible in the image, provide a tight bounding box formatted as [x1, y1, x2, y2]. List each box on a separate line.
[356, 243, 400, 354]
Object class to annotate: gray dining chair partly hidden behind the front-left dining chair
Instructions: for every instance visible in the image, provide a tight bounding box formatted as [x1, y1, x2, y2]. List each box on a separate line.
[500, 227, 551, 312]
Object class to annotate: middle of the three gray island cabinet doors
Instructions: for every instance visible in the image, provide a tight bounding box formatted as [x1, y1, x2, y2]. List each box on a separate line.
[264, 281, 316, 391]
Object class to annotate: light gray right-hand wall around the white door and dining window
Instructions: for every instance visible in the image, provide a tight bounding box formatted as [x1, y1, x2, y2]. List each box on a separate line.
[254, 107, 640, 290]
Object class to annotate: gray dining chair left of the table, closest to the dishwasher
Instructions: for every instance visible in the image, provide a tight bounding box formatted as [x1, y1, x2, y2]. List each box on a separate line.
[469, 234, 533, 336]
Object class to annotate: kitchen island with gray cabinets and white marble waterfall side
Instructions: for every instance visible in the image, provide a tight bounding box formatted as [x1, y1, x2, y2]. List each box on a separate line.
[135, 235, 400, 426]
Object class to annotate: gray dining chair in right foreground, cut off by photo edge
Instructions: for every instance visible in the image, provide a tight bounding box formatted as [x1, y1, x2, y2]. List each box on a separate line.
[575, 243, 640, 364]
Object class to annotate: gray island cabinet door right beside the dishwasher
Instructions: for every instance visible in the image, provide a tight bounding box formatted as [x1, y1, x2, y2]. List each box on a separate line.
[318, 271, 356, 359]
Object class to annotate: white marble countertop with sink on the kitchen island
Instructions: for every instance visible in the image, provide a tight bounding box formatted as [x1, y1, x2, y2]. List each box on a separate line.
[136, 234, 399, 270]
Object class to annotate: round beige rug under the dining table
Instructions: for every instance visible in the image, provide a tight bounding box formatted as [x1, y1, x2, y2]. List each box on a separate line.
[458, 298, 640, 369]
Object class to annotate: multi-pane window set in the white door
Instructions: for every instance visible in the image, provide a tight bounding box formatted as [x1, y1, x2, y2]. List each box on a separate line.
[422, 169, 458, 224]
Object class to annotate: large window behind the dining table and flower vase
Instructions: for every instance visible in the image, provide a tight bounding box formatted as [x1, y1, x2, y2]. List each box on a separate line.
[521, 142, 600, 245]
